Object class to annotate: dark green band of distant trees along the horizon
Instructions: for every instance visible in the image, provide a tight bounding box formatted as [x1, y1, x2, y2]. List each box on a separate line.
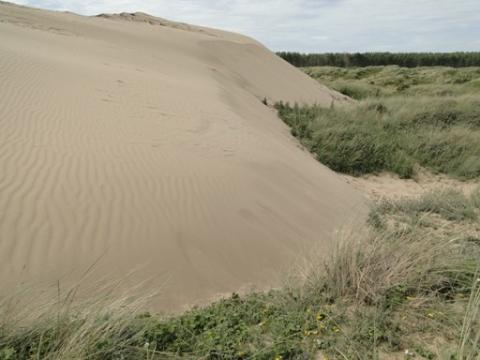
[277, 51, 480, 68]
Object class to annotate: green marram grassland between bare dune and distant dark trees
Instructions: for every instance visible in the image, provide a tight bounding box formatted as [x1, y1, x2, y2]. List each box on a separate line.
[276, 67, 480, 179]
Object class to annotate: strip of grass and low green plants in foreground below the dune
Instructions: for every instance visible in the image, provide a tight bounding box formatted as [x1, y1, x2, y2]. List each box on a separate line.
[0, 189, 480, 360]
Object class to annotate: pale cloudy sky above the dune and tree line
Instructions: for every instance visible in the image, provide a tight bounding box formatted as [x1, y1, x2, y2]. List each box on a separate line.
[10, 0, 480, 52]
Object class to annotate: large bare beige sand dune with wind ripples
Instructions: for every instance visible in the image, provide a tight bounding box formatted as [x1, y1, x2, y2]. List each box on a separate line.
[0, 3, 364, 308]
